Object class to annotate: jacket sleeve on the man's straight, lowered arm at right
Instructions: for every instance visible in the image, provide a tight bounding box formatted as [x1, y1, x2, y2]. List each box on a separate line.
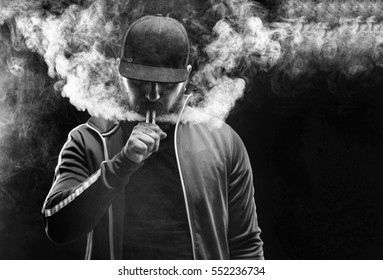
[228, 132, 264, 259]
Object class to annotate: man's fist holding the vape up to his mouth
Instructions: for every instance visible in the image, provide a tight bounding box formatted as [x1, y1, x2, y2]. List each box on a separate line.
[123, 122, 166, 163]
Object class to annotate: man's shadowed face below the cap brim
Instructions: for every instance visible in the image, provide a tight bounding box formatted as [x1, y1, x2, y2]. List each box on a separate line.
[122, 77, 186, 116]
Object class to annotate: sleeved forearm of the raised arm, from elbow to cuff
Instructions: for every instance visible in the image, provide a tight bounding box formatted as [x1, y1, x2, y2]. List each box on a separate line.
[43, 150, 141, 243]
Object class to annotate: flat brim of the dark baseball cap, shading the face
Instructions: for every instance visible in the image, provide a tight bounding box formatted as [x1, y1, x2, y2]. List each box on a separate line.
[119, 60, 189, 83]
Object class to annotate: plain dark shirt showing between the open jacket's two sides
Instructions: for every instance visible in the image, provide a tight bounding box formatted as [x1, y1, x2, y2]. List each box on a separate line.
[123, 124, 193, 260]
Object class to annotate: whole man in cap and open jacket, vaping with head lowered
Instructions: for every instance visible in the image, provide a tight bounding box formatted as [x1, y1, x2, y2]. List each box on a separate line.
[42, 15, 263, 259]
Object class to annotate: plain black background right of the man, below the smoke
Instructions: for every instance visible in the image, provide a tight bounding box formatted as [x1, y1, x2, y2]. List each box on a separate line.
[229, 73, 383, 259]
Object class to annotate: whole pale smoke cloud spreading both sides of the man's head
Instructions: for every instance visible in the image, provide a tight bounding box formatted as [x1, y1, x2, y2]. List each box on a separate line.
[0, 0, 383, 129]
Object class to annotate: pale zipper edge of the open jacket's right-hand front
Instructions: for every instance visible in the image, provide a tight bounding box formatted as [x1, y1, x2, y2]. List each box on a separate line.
[174, 94, 196, 260]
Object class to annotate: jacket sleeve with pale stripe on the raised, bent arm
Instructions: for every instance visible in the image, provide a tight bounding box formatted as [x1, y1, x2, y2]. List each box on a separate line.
[42, 130, 141, 244]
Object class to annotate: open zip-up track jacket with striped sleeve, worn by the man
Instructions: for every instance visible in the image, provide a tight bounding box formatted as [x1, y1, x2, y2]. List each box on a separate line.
[42, 101, 263, 259]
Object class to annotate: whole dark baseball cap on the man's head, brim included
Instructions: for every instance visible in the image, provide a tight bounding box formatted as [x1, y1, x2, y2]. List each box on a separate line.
[119, 15, 190, 83]
